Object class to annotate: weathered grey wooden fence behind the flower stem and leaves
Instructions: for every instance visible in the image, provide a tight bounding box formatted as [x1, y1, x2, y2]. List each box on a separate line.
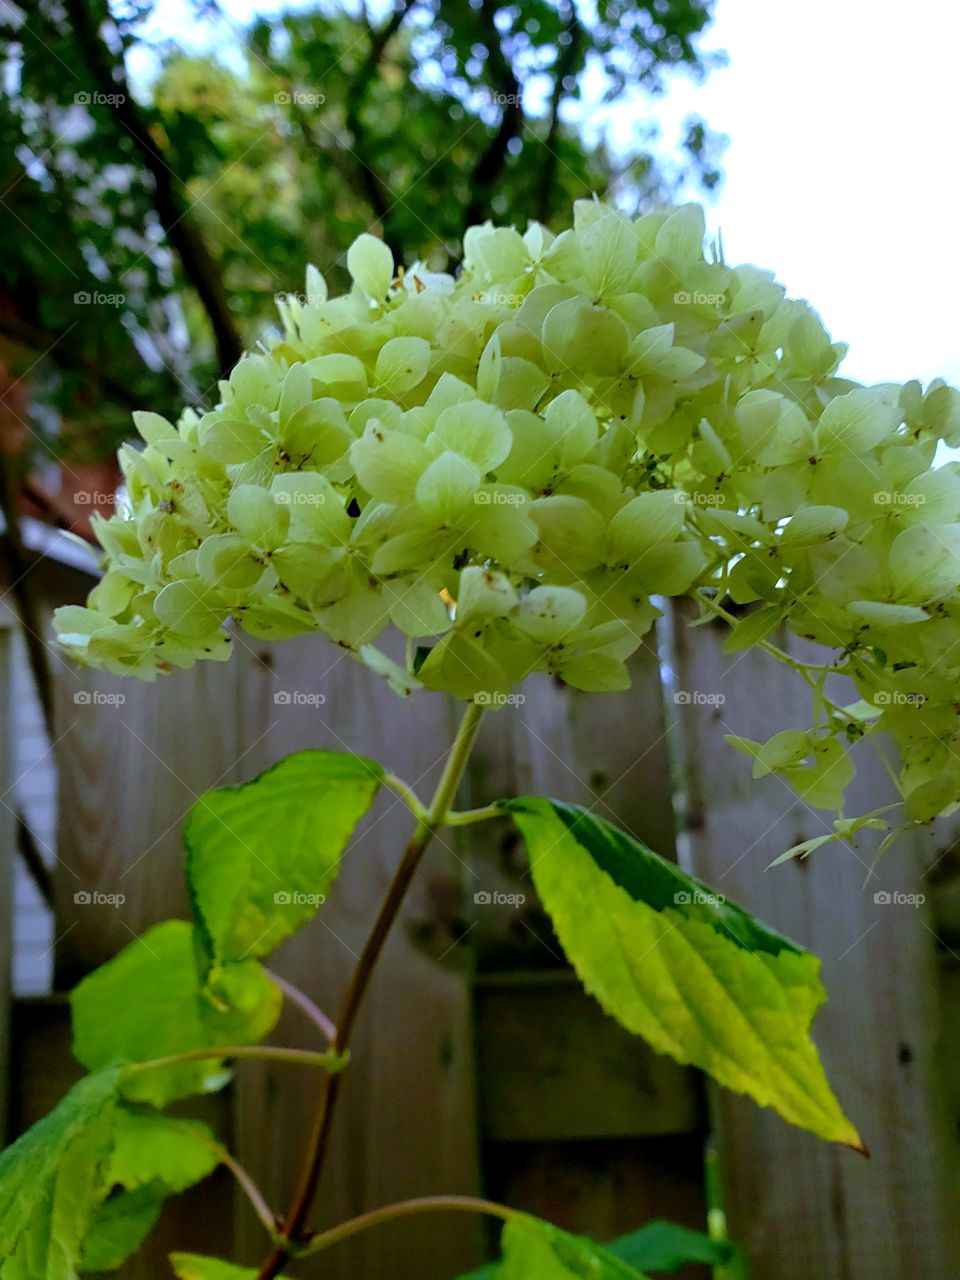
[0, 601, 960, 1280]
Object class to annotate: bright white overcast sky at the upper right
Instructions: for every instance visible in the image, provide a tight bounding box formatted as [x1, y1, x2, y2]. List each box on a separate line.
[135, 0, 960, 383]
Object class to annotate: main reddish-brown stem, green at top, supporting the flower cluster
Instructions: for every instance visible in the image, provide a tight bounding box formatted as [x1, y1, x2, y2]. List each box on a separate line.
[257, 703, 484, 1280]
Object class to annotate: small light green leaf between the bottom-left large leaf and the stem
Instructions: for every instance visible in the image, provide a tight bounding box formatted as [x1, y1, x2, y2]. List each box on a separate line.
[109, 1107, 220, 1192]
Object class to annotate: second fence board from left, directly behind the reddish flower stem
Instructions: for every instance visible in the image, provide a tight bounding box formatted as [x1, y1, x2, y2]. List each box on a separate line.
[192, 637, 480, 1280]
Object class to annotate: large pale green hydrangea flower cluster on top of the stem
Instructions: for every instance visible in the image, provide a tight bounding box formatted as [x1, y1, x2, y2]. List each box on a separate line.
[56, 201, 960, 817]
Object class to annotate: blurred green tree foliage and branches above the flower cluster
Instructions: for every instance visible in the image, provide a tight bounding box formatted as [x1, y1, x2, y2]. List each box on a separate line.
[0, 0, 722, 470]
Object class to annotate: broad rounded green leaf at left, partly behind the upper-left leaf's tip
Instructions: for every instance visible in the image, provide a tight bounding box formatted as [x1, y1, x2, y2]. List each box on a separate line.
[70, 920, 282, 1107]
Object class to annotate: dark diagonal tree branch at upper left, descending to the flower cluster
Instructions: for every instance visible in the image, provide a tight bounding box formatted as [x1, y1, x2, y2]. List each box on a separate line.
[65, 0, 243, 375]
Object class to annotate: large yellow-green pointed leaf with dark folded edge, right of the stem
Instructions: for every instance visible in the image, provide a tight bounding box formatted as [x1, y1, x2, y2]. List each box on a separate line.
[502, 797, 863, 1149]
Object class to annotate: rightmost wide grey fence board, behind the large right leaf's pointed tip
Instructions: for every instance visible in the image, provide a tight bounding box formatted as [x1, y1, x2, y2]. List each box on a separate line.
[676, 601, 960, 1280]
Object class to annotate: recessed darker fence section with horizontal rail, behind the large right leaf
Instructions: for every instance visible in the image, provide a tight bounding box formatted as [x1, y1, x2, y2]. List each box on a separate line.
[457, 644, 705, 1239]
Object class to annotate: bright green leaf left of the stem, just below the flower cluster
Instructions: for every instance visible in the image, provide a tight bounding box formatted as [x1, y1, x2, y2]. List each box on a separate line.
[184, 751, 383, 961]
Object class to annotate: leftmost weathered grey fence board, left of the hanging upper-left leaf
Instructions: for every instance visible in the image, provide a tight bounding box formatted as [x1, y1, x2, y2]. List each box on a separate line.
[55, 663, 239, 986]
